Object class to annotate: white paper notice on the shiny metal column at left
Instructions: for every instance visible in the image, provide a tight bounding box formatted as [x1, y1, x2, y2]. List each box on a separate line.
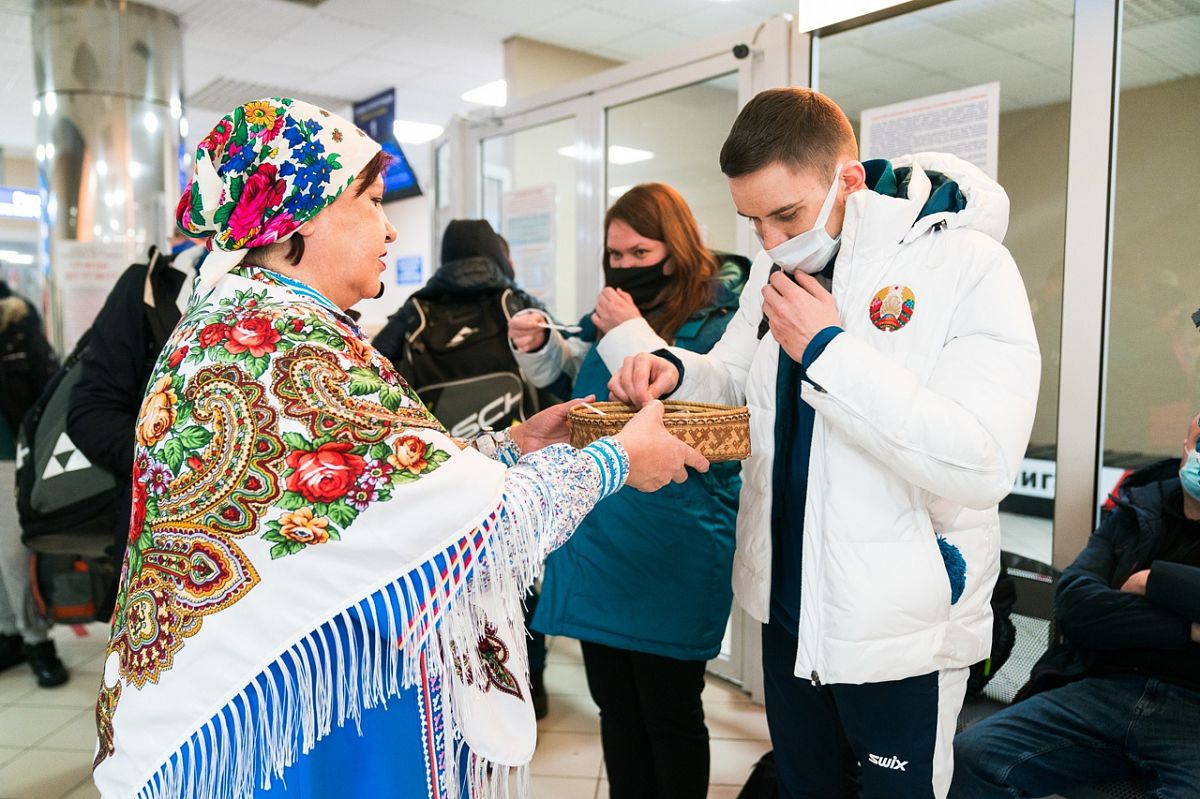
[52, 239, 133, 352]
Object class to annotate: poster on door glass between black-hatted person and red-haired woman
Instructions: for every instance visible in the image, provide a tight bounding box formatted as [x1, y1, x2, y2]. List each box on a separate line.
[502, 185, 557, 307]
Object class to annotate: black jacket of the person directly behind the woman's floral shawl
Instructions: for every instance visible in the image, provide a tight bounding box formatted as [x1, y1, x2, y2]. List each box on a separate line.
[67, 247, 204, 604]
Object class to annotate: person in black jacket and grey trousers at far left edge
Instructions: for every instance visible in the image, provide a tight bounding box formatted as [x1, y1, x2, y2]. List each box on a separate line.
[0, 281, 67, 687]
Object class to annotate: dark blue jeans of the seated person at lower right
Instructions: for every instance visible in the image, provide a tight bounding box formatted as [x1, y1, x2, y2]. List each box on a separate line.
[950, 673, 1200, 799]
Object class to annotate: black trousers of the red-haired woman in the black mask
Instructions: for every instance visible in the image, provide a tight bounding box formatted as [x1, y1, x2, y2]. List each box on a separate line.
[580, 641, 708, 799]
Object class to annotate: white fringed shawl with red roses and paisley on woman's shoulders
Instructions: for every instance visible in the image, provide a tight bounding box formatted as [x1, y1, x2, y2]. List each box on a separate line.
[95, 266, 545, 799]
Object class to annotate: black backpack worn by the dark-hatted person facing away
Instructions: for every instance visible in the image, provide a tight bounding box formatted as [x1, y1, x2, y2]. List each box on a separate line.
[397, 288, 538, 438]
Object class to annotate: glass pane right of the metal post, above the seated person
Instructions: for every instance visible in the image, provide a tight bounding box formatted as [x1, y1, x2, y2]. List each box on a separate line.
[1098, 2, 1200, 484]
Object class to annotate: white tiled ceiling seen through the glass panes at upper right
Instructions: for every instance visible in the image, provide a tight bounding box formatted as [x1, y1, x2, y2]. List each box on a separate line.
[818, 0, 1200, 121]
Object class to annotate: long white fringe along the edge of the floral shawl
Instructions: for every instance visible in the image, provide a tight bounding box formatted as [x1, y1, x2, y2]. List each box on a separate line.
[137, 497, 552, 799]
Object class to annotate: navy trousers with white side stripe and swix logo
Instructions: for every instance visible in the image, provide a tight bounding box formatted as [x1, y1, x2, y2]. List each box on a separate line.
[762, 620, 967, 799]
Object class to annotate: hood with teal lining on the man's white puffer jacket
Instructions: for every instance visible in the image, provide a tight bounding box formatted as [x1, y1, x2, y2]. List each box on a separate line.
[842, 152, 1008, 257]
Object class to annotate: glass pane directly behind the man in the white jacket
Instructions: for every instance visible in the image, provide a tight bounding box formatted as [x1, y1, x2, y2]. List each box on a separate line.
[815, 0, 1074, 563]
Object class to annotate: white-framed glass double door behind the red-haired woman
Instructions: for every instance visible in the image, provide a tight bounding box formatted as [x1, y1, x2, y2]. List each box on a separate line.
[456, 17, 806, 699]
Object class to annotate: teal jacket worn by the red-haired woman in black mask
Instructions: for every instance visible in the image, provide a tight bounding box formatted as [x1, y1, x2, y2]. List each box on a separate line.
[532, 253, 750, 660]
